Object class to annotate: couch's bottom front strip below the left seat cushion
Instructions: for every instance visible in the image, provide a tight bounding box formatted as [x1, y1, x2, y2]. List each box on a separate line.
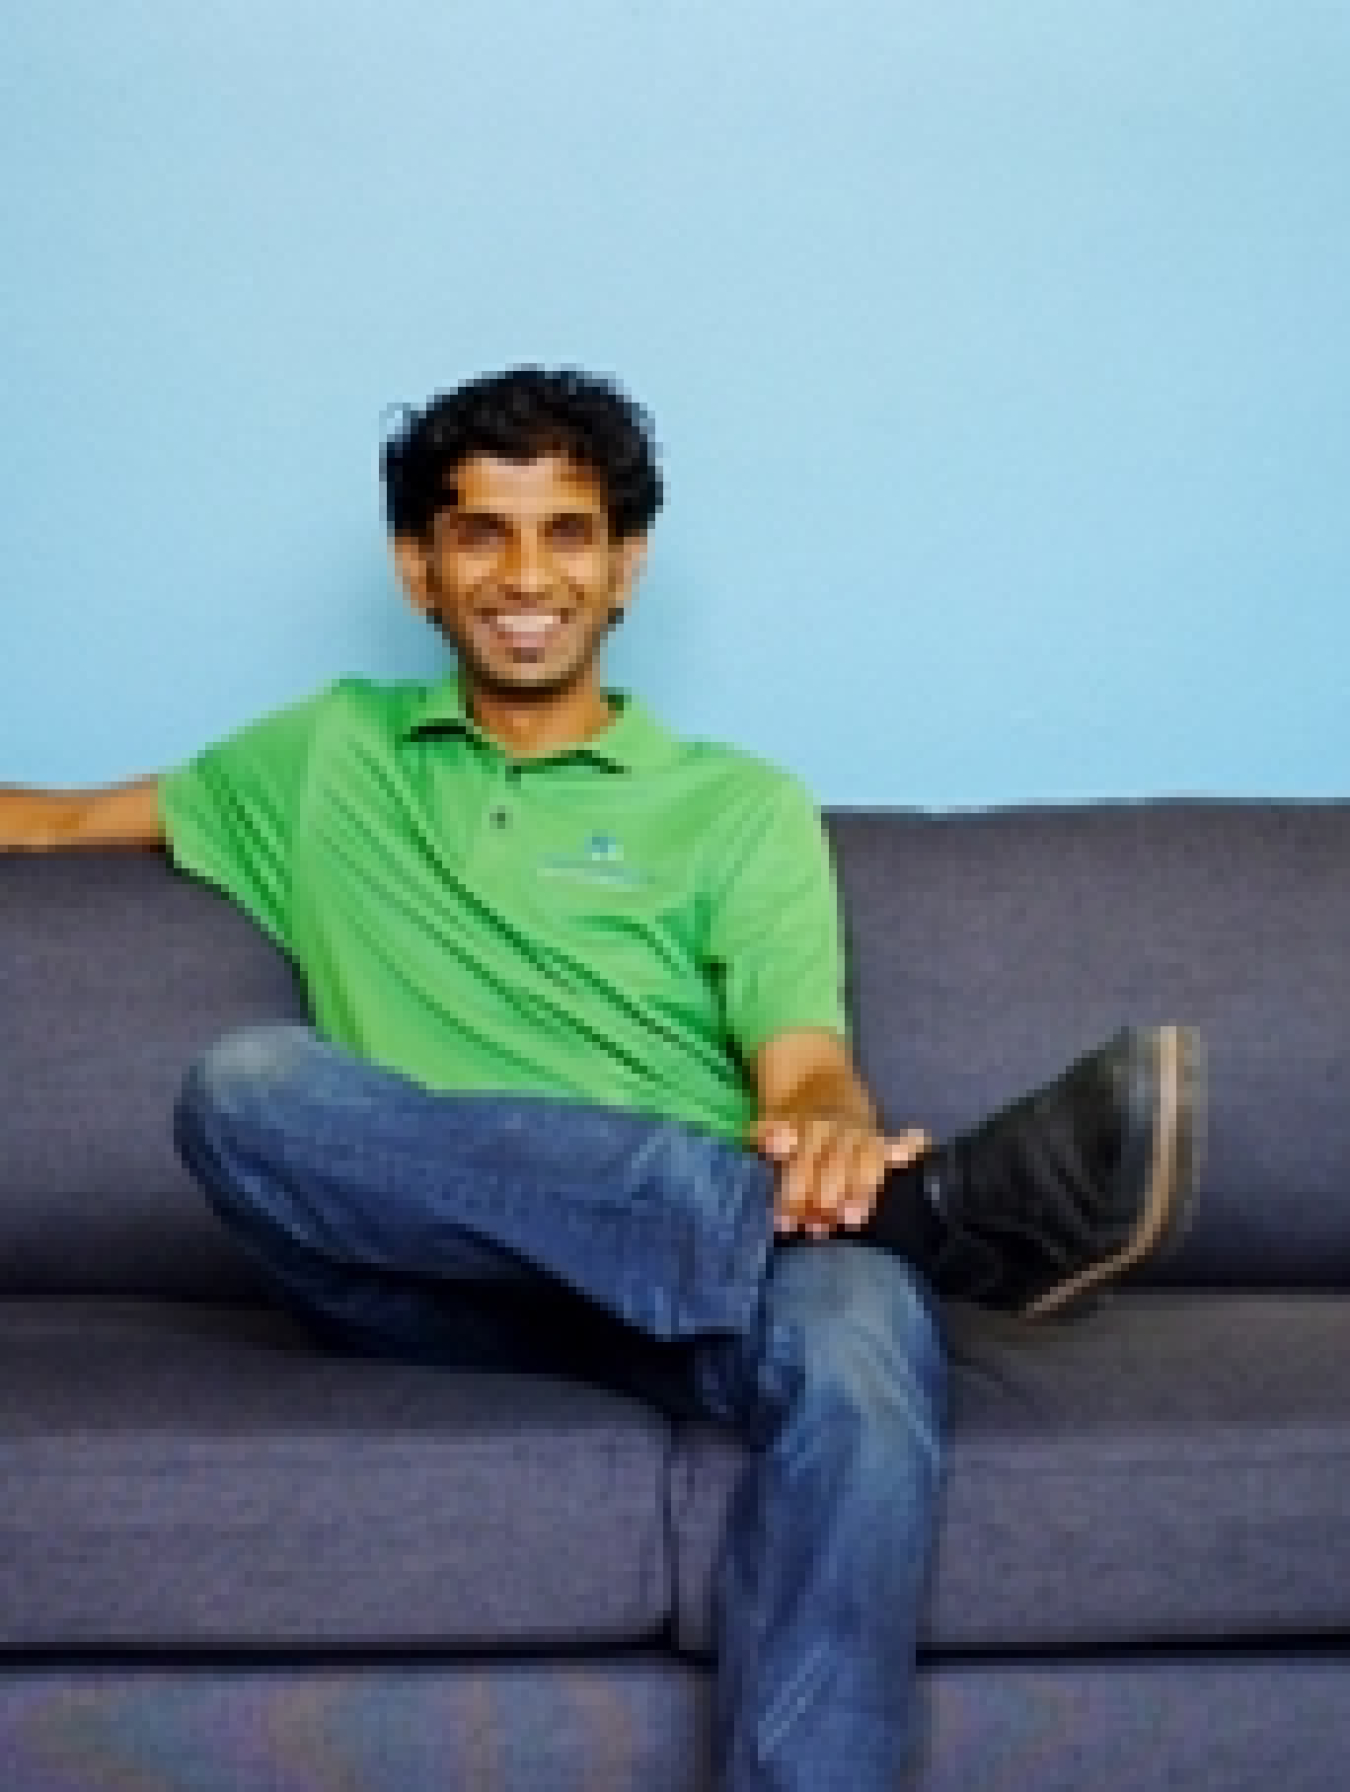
[0, 1654, 708, 1792]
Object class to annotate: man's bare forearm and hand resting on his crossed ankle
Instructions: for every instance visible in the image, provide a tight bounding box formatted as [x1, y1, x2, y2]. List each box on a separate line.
[751, 1029, 930, 1238]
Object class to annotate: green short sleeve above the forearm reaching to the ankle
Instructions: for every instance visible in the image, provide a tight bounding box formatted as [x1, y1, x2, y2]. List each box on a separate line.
[708, 774, 848, 1059]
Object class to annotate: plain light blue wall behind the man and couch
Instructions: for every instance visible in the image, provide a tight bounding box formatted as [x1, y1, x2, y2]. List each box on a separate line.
[0, 0, 1350, 806]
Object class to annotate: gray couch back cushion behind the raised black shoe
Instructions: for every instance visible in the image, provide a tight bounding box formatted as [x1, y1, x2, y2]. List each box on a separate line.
[830, 803, 1350, 1287]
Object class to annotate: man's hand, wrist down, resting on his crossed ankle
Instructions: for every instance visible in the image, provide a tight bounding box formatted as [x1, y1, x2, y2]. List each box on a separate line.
[755, 1115, 930, 1238]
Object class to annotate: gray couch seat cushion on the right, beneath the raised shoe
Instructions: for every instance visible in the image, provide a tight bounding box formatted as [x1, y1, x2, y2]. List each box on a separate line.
[671, 1290, 1350, 1652]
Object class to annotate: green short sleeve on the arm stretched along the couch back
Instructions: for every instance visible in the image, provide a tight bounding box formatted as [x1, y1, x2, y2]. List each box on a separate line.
[160, 695, 325, 950]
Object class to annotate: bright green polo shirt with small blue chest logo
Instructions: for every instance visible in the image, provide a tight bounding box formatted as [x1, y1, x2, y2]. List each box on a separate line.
[161, 679, 844, 1138]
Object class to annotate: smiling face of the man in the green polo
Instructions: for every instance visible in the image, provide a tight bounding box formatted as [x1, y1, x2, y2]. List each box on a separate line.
[414, 455, 642, 697]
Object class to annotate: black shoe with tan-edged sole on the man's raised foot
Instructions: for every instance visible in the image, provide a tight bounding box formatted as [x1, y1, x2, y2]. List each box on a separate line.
[918, 1027, 1205, 1319]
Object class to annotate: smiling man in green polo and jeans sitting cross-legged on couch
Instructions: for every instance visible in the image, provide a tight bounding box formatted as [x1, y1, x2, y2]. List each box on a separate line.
[0, 369, 1199, 1792]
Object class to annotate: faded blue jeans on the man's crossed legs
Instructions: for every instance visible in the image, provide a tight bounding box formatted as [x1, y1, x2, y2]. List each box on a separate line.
[176, 1025, 943, 1792]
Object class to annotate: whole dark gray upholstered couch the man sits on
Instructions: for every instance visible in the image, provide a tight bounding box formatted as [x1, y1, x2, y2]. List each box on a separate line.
[0, 803, 1350, 1792]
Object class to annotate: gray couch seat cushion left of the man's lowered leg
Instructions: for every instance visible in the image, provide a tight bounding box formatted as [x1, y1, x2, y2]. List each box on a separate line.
[0, 1299, 671, 1652]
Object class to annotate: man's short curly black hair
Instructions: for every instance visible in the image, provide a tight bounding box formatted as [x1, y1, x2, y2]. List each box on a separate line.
[380, 367, 662, 541]
